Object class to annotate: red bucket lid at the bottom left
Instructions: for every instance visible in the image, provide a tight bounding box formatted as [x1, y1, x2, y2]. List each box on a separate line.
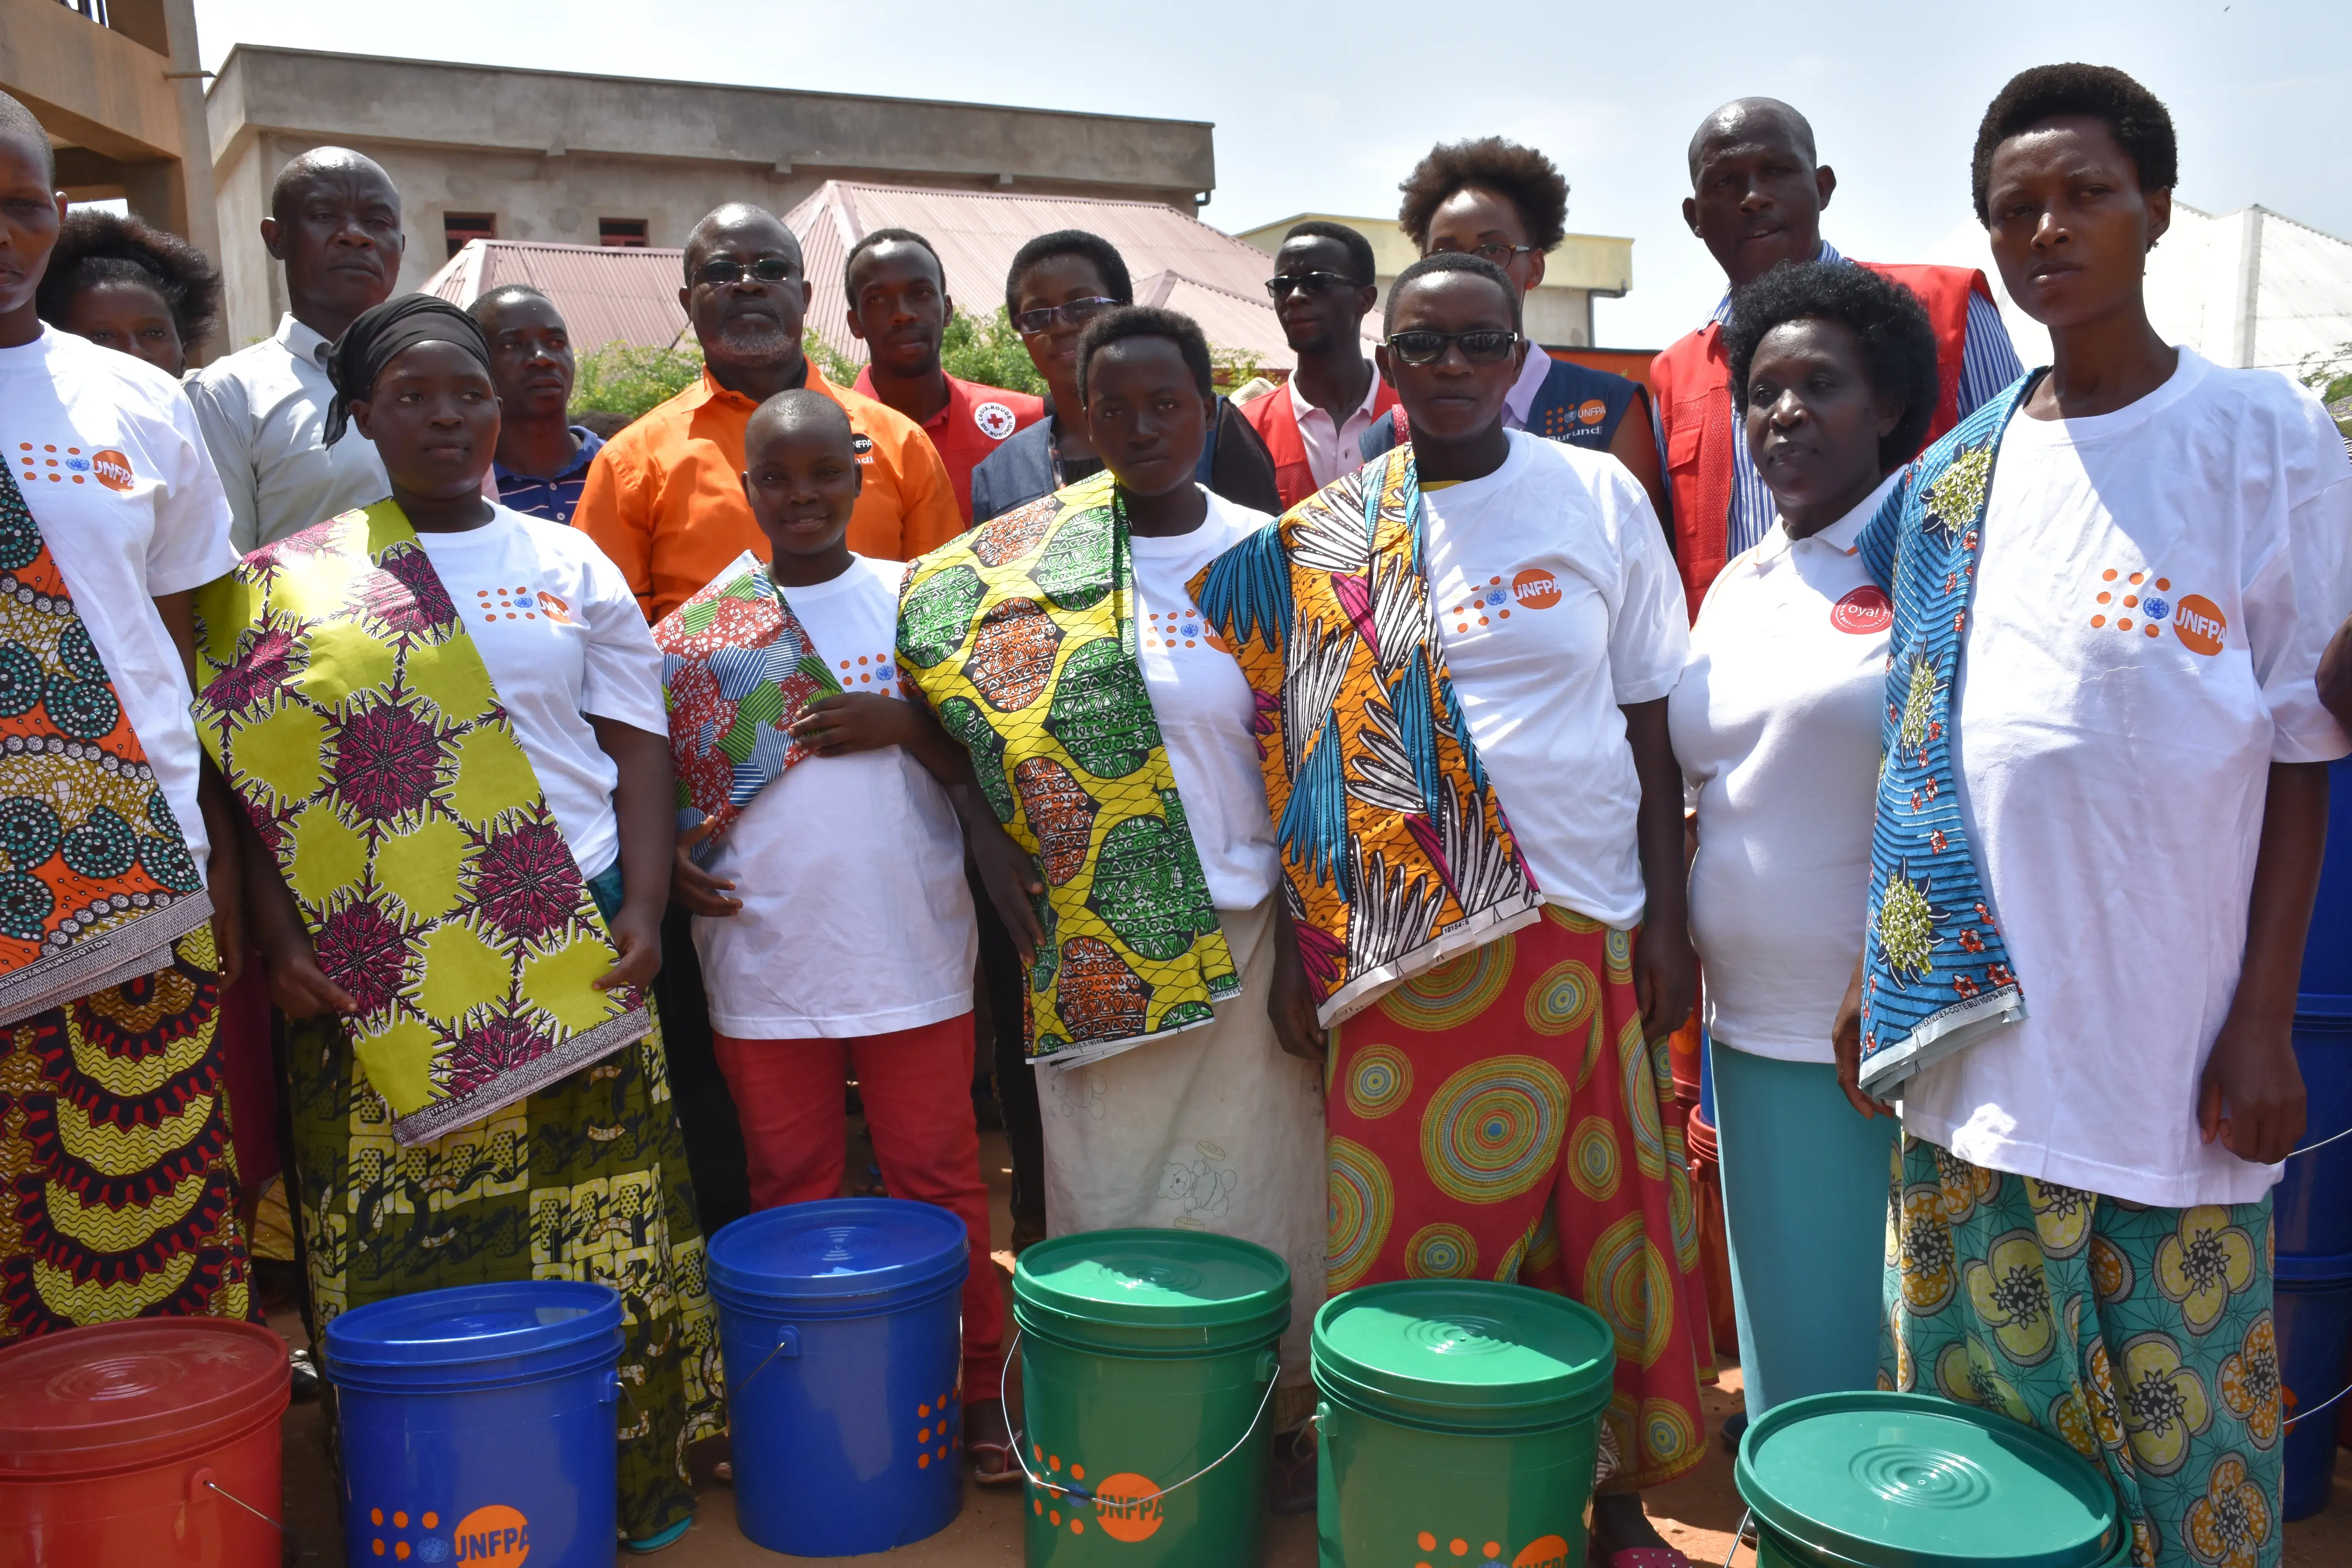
[0, 1316, 289, 1479]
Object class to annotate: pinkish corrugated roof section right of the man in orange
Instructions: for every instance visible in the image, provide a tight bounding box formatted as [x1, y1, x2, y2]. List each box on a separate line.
[783, 179, 1369, 374]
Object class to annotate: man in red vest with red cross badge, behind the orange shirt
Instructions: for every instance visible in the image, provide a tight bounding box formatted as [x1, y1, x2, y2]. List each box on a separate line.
[842, 228, 1044, 529]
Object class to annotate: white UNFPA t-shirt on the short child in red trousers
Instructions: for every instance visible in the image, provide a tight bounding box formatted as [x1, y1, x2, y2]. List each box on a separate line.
[694, 555, 978, 1039]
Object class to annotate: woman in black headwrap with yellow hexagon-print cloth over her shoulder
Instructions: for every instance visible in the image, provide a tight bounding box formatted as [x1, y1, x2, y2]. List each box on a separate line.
[234, 294, 720, 1549]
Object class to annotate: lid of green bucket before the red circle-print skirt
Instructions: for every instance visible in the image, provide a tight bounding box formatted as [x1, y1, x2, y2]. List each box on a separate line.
[1315, 1279, 1616, 1432]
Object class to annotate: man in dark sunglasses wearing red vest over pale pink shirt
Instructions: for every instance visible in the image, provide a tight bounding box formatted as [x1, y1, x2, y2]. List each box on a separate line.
[1242, 219, 1397, 508]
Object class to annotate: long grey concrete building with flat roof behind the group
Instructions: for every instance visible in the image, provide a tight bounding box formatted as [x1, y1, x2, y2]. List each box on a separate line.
[212, 45, 1216, 343]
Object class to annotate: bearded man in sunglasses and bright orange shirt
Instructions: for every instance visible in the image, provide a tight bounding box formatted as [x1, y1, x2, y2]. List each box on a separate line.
[572, 202, 964, 621]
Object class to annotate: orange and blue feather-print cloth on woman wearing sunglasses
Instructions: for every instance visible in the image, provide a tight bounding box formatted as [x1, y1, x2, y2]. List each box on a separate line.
[1192, 446, 1543, 1025]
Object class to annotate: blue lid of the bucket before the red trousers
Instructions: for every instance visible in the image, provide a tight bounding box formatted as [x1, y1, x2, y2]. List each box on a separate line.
[710, 1199, 971, 1309]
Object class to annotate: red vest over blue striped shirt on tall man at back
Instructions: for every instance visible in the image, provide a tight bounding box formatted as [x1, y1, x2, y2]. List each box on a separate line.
[1649, 261, 1992, 621]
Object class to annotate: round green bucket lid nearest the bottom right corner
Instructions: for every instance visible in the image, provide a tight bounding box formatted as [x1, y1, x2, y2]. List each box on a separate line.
[1733, 1392, 2124, 1568]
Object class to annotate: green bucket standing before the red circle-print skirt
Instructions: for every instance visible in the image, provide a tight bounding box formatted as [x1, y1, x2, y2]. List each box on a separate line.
[1315, 1279, 1616, 1568]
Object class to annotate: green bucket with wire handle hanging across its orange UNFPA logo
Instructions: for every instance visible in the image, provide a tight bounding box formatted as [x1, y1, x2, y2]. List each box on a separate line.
[1014, 1229, 1291, 1568]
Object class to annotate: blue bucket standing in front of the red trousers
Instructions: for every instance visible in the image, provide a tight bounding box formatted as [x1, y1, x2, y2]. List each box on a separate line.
[710, 1199, 974, 1556]
